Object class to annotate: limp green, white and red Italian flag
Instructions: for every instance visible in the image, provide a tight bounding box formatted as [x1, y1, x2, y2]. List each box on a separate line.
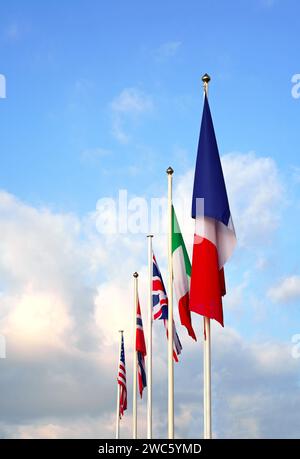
[172, 206, 197, 341]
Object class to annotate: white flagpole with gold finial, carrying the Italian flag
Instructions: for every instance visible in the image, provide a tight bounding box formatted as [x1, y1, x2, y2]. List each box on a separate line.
[166, 167, 174, 440]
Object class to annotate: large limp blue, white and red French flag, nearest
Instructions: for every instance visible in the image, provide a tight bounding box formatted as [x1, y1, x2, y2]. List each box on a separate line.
[190, 95, 236, 326]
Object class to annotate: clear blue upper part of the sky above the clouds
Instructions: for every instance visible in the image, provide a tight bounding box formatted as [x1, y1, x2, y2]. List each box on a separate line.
[0, 0, 300, 213]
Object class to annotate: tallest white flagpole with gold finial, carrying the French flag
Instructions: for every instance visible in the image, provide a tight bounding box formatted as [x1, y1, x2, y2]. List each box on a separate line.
[202, 73, 212, 439]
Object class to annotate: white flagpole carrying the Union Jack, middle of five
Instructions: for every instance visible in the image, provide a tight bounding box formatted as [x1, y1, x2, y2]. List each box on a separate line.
[147, 234, 153, 439]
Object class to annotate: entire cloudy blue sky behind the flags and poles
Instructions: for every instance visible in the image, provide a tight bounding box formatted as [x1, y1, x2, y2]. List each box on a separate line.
[0, 0, 300, 438]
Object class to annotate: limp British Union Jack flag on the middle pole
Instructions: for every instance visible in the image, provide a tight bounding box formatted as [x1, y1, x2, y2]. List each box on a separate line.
[152, 254, 182, 362]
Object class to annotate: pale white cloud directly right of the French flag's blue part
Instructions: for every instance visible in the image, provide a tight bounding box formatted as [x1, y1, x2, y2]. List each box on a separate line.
[222, 153, 285, 246]
